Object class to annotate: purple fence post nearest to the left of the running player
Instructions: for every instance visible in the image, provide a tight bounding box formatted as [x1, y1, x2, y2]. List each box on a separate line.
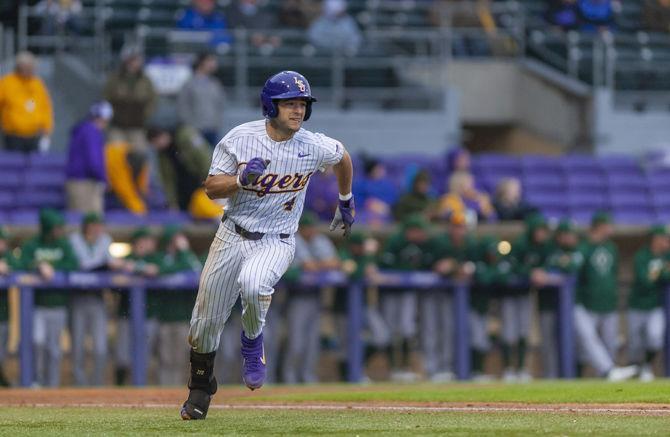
[130, 285, 147, 386]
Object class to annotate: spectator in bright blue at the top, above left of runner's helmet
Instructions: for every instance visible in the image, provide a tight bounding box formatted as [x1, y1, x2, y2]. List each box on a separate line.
[177, 0, 233, 51]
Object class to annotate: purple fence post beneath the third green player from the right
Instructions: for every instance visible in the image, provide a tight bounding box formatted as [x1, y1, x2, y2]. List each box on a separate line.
[558, 276, 577, 378]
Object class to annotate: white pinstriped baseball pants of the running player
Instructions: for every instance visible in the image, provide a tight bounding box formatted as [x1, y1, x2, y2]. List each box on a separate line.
[188, 220, 295, 353]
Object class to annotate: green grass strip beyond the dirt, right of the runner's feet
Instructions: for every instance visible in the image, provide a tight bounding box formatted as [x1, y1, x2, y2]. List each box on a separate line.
[240, 380, 670, 404]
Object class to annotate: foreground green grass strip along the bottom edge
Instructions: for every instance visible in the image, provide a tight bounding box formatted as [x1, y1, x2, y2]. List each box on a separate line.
[0, 407, 670, 437]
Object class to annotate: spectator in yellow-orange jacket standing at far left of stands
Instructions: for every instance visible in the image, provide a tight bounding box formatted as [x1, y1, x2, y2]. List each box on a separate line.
[0, 52, 53, 153]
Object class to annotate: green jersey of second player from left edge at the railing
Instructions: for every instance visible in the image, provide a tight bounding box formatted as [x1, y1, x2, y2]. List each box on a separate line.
[19, 236, 79, 307]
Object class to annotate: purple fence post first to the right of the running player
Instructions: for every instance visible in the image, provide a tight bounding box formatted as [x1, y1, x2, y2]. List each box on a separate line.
[347, 281, 364, 382]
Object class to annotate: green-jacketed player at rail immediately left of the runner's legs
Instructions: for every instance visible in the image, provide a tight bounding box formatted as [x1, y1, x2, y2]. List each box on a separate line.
[153, 226, 202, 386]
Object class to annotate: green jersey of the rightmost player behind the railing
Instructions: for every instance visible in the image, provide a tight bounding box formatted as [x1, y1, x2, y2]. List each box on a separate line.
[628, 246, 670, 311]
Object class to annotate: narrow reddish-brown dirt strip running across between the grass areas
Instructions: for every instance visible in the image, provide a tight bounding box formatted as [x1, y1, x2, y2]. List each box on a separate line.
[0, 387, 670, 417]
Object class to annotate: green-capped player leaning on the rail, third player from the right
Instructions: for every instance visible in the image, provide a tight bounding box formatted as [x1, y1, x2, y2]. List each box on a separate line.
[530, 220, 584, 379]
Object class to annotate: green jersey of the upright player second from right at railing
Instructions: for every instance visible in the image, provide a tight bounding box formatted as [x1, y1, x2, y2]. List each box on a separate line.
[576, 240, 619, 313]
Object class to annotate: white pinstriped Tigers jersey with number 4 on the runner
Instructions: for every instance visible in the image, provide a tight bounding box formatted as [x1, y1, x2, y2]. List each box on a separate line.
[209, 120, 344, 234]
